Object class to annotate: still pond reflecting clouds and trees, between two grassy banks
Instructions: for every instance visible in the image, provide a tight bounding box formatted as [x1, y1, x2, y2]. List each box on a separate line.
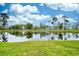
[0, 32, 79, 42]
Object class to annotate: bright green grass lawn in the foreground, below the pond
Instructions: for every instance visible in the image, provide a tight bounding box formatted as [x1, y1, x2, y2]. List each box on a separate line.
[0, 41, 79, 56]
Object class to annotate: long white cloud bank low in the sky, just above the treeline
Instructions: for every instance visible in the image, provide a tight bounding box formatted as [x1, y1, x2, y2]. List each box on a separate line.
[8, 14, 50, 26]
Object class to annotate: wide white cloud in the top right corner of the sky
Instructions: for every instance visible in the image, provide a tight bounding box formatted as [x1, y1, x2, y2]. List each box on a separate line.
[45, 3, 79, 11]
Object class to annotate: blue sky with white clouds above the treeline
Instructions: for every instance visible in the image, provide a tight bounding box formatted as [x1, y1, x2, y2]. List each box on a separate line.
[0, 3, 79, 26]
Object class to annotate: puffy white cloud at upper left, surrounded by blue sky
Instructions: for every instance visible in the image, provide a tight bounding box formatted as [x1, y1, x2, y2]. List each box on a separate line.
[11, 4, 38, 13]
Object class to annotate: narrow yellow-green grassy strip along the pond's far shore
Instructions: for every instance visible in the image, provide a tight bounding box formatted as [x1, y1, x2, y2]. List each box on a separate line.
[0, 29, 79, 33]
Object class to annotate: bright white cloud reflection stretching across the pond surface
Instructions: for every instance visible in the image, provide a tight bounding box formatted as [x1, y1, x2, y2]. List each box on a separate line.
[0, 33, 79, 42]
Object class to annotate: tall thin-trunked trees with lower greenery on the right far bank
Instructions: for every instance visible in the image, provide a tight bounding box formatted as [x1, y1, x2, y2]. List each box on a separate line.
[50, 16, 78, 30]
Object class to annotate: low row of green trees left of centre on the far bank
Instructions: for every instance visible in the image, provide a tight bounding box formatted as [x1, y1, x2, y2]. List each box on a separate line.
[9, 23, 49, 30]
